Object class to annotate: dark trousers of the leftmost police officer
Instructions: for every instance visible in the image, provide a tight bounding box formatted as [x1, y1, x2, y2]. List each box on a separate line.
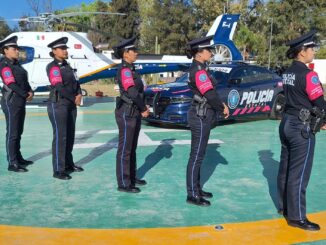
[1, 97, 26, 165]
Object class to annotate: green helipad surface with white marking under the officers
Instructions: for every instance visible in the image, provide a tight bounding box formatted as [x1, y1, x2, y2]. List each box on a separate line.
[0, 97, 326, 244]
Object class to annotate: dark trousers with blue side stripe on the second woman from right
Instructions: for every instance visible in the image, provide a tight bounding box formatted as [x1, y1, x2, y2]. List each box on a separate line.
[187, 106, 215, 196]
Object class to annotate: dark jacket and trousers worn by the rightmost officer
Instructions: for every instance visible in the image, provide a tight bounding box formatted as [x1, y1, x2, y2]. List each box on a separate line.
[278, 61, 326, 220]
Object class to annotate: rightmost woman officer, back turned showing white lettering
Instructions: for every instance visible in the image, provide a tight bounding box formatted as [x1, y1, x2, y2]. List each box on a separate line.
[277, 31, 326, 230]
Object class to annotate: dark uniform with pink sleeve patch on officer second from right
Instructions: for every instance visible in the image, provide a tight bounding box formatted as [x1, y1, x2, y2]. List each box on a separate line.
[187, 60, 224, 198]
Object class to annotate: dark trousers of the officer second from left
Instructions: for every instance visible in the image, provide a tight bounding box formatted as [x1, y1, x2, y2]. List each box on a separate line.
[48, 102, 77, 172]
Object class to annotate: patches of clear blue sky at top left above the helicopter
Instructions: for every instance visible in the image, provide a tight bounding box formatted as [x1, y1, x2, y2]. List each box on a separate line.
[0, 0, 106, 27]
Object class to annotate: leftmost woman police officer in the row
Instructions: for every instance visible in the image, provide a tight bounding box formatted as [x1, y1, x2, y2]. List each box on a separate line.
[0, 36, 34, 172]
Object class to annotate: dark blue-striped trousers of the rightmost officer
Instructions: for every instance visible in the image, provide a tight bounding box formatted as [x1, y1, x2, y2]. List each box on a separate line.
[277, 113, 315, 220]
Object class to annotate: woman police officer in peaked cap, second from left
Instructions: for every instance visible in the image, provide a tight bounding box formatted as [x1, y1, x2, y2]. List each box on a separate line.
[46, 37, 83, 180]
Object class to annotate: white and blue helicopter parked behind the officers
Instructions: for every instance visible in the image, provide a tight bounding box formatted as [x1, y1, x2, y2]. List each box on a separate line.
[0, 12, 242, 92]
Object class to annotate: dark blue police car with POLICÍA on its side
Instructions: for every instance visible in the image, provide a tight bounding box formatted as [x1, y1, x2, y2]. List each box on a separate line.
[144, 63, 285, 125]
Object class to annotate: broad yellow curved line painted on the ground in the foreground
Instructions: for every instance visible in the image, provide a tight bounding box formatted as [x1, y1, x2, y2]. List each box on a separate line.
[0, 211, 326, 245]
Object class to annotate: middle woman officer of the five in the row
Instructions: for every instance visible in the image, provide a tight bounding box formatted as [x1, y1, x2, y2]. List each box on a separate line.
[113, 38, 149, 193]
